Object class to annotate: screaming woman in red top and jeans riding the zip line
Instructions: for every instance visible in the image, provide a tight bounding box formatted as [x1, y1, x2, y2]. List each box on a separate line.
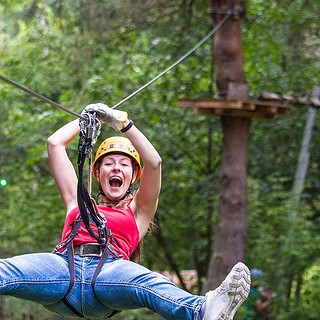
[0, 104, 250, 320]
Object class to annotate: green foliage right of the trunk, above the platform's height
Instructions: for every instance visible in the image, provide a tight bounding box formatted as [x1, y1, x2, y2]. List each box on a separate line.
[244, 0, 319, 95]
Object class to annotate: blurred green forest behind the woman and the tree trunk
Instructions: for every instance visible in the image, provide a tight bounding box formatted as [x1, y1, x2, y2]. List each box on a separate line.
[0, 0, 320, 320]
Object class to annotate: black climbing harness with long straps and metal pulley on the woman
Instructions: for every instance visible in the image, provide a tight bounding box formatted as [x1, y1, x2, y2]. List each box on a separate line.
[53, 112, 122, 318]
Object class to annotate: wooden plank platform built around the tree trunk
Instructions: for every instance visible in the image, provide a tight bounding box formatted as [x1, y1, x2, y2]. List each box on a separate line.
[179, 99, 290, 119]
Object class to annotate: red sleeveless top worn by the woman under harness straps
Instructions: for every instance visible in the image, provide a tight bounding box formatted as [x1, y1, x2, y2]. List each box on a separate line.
[61, 206, 140, 260]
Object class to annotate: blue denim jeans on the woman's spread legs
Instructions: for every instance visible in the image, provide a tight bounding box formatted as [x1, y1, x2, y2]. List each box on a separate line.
[0, 253, 205, 320]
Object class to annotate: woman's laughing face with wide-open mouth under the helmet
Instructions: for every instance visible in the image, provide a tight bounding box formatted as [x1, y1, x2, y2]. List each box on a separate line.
[98, 154, 135, 200]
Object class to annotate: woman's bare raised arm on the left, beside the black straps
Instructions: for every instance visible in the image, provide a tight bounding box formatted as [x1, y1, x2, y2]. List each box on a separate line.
[47, 119, 80, 213]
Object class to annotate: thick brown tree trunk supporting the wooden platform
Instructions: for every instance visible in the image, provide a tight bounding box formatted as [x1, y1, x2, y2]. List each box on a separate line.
[205, 0, 250, 291]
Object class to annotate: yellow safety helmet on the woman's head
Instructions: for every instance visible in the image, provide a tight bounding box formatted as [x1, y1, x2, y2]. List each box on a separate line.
[92, 136, 142, 184]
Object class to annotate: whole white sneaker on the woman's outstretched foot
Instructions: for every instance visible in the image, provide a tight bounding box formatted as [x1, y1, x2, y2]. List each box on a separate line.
[203, 262, 251, 320]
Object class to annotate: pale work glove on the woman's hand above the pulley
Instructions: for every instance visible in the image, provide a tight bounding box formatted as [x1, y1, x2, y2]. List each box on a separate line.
[81, 103, 128, 132]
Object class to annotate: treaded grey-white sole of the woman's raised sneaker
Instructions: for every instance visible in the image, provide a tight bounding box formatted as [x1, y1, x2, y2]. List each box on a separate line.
[217, 262, 251, 320]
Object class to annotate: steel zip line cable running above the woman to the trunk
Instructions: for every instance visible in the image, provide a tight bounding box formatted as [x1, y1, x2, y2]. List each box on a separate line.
[0, 10, 232, 119]
